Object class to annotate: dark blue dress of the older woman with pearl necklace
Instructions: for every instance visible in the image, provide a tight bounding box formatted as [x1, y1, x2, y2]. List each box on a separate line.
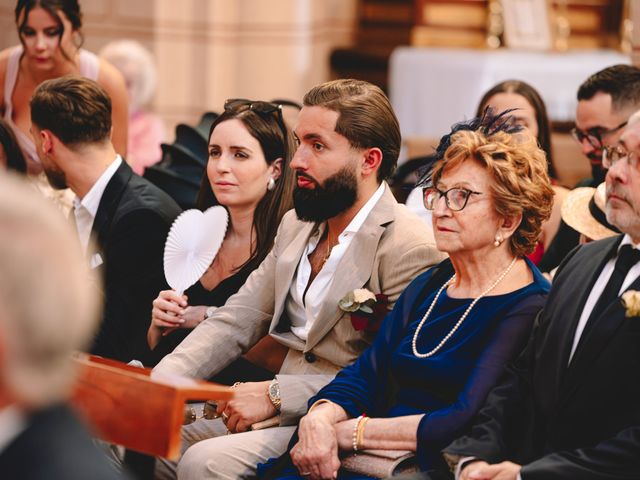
[259, 260, 550, 478]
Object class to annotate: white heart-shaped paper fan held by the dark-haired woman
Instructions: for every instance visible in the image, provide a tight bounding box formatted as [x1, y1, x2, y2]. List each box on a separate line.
[164, 206, 229, 295]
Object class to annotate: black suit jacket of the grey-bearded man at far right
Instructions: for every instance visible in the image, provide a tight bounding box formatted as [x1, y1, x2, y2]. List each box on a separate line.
[445, 236, 640, 480]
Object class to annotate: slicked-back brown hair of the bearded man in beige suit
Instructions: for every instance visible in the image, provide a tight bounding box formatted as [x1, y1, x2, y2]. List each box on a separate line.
[303, 78, 402, 182]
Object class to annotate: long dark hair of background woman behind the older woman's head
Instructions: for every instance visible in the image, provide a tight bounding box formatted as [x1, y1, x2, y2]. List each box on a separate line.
[476, 80, 557, 179]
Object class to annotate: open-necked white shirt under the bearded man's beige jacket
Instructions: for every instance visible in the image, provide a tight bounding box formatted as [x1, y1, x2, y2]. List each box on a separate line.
[286, 182, 385, 341]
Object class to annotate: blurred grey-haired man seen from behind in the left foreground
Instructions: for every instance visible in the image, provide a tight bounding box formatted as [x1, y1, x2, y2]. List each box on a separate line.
[0, 175, 127, 480]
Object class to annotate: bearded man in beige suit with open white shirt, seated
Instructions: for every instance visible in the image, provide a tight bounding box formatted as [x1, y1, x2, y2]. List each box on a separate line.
[155, 80, 444, 479]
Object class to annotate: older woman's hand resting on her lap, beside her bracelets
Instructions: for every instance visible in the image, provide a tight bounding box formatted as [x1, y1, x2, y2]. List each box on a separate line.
[291, 413, 340, 480]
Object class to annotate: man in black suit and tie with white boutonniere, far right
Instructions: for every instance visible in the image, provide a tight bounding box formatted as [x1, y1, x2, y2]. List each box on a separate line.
[445, 112, 640, 480]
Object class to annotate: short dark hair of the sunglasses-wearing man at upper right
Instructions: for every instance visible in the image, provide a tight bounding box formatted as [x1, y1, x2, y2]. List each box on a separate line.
[578, 65, 640, 111]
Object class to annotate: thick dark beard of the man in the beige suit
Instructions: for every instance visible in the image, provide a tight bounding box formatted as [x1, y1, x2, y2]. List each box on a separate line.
[293, 167, 358, 222]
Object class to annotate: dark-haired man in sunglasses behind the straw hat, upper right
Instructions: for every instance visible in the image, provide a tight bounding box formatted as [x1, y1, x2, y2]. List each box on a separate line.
[538, 65, 640, 272]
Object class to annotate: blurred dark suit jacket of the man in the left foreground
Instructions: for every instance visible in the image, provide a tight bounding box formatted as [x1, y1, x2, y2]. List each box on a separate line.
[0, 405, 125, 480]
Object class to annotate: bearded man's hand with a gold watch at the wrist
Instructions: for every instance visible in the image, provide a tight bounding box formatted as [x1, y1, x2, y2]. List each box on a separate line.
[217, 381, 278, 433]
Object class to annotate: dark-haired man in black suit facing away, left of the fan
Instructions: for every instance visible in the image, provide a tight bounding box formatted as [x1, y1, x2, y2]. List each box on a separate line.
[31, 76, 180, 361]
